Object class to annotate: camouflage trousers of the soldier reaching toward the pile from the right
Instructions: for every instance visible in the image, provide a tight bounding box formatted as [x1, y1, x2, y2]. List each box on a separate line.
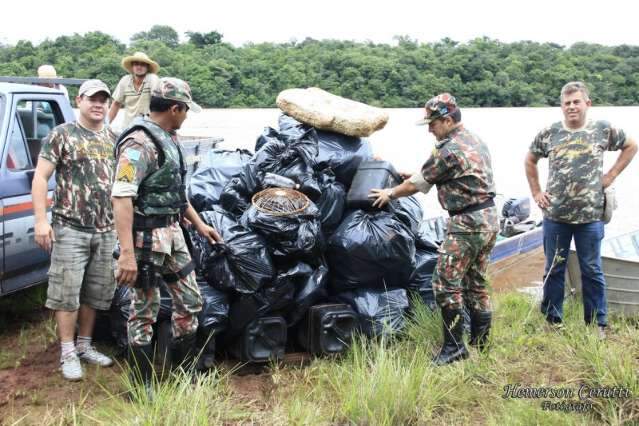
[433, 232, 497, 311]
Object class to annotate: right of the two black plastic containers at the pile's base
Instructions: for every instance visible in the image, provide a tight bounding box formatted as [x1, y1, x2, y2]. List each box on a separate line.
[297, 304, 358, 355]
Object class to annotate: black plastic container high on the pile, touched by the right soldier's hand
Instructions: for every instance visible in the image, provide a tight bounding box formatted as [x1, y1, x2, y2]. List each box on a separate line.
[346, 160, 402, 210]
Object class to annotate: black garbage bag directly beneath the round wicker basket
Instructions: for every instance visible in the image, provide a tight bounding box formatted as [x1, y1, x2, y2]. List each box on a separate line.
[240, 202, 324, 260]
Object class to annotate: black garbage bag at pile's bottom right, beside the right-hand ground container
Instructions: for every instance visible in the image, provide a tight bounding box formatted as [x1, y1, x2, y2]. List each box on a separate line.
[337, 288, 408, 337]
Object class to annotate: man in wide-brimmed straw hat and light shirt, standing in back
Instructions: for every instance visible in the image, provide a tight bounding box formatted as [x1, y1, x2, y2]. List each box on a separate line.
[108, 52, 160, 128]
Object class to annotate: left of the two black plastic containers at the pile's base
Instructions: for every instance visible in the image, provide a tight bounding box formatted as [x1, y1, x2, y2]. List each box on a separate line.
[229, 316, 287, 362]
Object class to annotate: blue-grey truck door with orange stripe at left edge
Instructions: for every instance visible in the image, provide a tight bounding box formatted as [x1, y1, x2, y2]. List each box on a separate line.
[0, 94, 64, 294]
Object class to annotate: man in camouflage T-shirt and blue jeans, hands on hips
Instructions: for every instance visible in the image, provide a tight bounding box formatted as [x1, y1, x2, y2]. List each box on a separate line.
[525, 82, 637, 338]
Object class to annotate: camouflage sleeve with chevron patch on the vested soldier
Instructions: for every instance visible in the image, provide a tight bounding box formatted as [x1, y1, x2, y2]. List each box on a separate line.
[112, 131, 158, 198]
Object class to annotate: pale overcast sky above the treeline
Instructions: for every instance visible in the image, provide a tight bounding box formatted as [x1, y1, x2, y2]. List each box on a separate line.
[0, 0, 639, 46]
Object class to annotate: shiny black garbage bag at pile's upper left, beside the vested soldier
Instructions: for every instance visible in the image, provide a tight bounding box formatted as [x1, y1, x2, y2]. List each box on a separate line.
[189, 149, 252, 212]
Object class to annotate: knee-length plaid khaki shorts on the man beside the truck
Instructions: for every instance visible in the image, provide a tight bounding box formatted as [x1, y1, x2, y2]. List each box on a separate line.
[45, 224, 116, 311]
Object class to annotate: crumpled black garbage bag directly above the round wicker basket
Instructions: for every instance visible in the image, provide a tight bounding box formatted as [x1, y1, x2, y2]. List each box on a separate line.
[251, 128, 321, 200]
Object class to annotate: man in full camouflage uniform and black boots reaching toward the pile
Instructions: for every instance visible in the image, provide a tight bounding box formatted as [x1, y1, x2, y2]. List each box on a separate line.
[370, 93, 499, 365]
